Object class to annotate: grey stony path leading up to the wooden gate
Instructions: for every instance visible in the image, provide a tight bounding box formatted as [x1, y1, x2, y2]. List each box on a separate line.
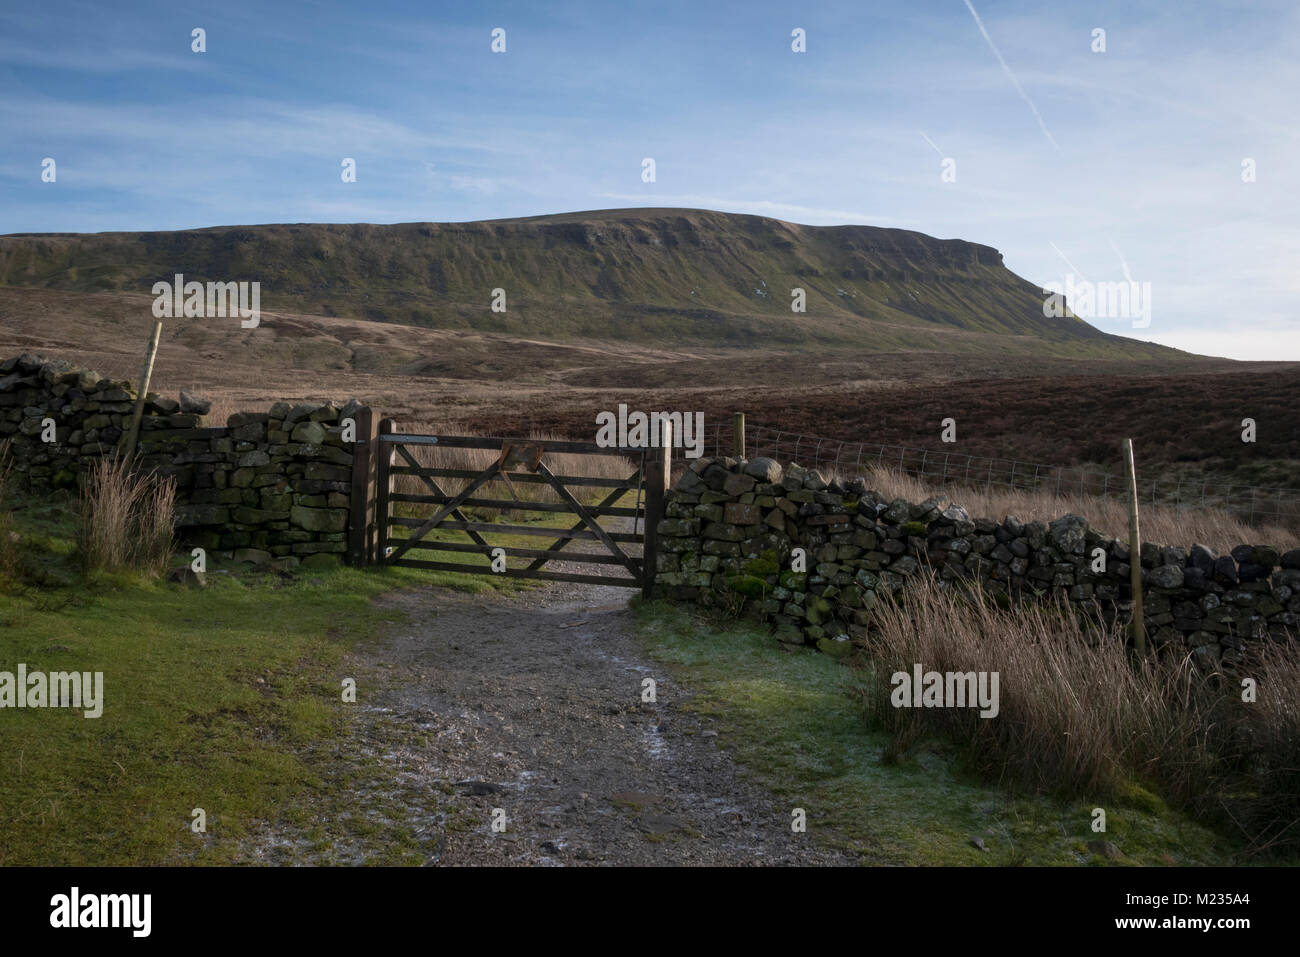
[340, 584, 853, 865]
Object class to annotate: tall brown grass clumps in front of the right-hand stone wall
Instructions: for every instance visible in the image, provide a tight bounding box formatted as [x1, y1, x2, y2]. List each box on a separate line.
[861, 581, 1300, 850]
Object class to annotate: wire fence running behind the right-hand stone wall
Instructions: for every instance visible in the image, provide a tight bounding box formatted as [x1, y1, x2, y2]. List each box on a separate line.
[703, 421, 1300, 527]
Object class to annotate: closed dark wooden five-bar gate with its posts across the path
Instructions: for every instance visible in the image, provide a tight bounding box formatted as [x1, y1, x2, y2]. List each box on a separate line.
[350, 410, 671, 597]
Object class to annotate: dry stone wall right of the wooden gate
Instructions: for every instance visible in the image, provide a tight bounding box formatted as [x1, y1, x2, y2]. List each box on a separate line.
[657, 458, 1300, 667]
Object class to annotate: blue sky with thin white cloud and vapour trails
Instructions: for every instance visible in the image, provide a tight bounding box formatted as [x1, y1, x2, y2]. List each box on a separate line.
[0, 0, 1300, 359]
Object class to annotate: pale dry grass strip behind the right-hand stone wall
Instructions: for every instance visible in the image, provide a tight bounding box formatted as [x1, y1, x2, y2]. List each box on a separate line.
[823, 468, 1300, 554]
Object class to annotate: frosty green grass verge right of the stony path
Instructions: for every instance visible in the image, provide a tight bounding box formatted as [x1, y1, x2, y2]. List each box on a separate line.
[638, 602, 1238, 866]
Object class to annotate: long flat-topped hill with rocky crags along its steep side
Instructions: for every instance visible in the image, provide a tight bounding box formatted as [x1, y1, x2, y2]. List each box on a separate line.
[0, 208, 1177, 358]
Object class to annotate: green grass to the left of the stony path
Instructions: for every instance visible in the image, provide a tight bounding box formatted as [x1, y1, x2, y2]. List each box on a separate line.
[0, 499, 512, 866]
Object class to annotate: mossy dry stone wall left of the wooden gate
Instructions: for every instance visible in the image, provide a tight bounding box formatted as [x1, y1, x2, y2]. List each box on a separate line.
[0, 355, 361, 567]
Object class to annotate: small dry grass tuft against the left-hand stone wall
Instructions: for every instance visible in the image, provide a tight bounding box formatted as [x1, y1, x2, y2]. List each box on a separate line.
[78, 458, 176, 576]
